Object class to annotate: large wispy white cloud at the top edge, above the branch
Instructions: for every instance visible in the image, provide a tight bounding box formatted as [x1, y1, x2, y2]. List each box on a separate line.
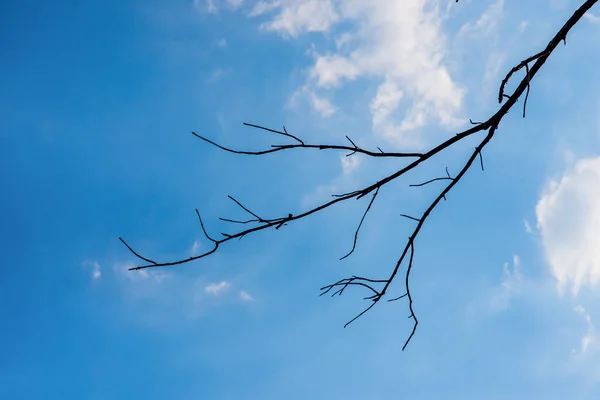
[246, 0, 464, 147]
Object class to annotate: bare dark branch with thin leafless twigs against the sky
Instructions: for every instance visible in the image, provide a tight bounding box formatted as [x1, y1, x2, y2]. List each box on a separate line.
[121, 0, 597, 350]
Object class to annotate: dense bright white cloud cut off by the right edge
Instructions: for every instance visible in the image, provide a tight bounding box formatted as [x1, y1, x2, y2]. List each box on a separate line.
[536, 157, 600, 294]
